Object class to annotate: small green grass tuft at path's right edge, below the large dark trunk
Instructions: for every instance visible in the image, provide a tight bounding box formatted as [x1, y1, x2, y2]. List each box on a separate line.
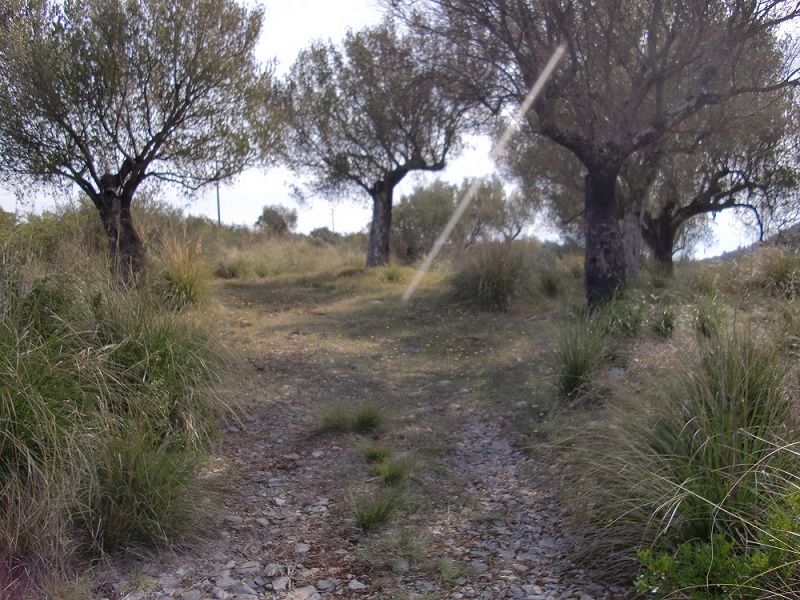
[554, 320, 608, 400]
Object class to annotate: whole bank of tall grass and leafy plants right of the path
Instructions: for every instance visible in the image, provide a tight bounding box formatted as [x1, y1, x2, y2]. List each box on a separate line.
[547, 249, 800, 599]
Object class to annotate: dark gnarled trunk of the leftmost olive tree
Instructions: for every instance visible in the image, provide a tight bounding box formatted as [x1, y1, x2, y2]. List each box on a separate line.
[95, 175, 145, 284]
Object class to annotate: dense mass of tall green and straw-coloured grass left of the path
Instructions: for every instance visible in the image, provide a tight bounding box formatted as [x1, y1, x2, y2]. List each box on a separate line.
[0, 244, 225, 572]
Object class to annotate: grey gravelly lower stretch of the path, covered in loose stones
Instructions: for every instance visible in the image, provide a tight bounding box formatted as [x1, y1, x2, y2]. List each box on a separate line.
[98, 288, 625, 600]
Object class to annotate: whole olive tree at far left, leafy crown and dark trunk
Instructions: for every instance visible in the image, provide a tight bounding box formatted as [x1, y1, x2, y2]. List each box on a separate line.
[0, 0, 271, 279]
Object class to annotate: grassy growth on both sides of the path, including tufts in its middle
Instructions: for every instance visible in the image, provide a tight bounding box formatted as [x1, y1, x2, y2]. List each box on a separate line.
[0, 200, 800, 598]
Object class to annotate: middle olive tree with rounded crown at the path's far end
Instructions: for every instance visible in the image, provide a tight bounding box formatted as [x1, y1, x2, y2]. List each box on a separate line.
[284, 22, 469, 267]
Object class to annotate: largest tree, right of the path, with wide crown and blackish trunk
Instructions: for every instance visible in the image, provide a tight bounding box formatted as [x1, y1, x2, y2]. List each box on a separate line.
[392, 0, 800, 305]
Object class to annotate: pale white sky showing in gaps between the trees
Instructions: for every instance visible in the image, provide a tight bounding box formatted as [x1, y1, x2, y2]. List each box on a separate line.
[0, 0, 755, 256]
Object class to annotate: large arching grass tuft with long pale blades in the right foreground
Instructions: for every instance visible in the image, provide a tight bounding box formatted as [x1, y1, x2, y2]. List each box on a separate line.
[573, 336, 800, 598]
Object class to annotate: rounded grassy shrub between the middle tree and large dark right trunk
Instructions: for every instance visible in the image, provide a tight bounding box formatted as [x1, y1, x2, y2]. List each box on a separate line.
[451, 244, 530, 312]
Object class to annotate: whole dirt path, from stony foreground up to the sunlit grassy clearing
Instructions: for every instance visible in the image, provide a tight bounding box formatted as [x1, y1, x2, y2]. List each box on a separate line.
[100, 282, 623, 600]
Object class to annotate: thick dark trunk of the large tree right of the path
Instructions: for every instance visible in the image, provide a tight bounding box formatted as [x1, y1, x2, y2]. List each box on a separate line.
[585, 166, 625, 309]
